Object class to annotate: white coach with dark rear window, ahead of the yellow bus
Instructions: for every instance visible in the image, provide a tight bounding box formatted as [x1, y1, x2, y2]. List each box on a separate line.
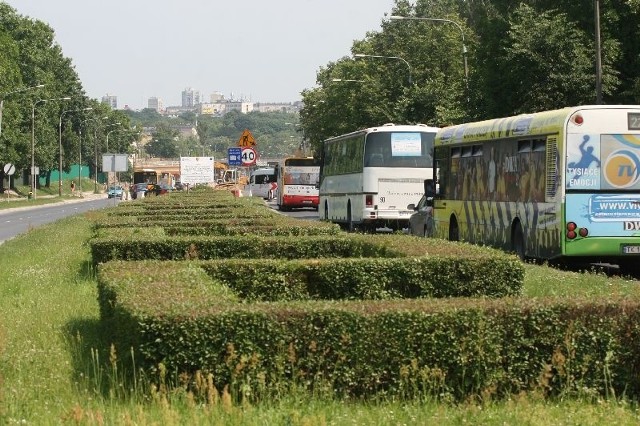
[318, 124, 439, 231]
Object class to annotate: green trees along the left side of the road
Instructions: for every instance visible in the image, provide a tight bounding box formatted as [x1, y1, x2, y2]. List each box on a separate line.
[0, 2, 137, 191]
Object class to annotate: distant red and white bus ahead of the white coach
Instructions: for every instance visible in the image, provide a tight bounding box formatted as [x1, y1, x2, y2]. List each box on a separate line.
[277, 157, 320, 211]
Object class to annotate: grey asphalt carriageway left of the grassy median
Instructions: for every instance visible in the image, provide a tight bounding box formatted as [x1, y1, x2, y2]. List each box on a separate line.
[0, 194, 119, 244]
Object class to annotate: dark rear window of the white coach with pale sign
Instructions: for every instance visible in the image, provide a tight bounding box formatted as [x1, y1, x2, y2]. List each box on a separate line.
[364, 132, 435, 168]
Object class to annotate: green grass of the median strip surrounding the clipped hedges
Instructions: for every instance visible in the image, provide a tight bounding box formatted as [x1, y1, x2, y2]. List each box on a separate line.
[0, 216, 640, 425]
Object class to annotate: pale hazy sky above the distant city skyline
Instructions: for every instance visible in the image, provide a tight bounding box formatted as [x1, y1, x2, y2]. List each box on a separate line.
[0, 0, 395, 109]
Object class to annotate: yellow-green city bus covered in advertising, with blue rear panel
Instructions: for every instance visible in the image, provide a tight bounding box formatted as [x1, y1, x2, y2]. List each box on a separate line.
[425, 105, 640, 272]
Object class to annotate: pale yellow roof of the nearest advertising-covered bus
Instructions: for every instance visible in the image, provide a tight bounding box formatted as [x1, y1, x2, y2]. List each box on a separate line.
[435, 105, 638, 145]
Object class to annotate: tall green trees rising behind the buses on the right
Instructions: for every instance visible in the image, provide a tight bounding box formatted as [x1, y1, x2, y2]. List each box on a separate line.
[300, 0, 640, 155]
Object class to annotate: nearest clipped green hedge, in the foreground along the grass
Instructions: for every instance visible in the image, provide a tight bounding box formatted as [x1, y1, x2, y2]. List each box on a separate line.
[99, 259, 640, 400]
